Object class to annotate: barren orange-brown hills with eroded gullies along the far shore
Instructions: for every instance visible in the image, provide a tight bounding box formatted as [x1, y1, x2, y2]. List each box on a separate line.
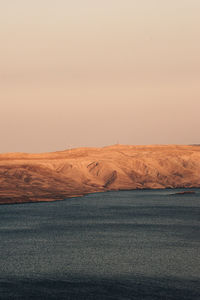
[0, 145, 200, 203]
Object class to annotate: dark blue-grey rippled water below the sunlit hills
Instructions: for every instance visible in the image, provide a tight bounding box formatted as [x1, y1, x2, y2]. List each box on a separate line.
[0, 189, 200, 299]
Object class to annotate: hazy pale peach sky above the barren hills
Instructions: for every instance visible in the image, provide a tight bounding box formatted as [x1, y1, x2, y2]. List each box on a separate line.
[0, 0, 200, 152]
